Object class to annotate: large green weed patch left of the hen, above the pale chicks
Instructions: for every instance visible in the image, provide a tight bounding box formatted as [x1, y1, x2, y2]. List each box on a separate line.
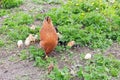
[0, 12, 39, 41]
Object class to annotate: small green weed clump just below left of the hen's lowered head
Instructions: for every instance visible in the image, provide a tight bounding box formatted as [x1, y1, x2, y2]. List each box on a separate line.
[29, 46, 56, 67]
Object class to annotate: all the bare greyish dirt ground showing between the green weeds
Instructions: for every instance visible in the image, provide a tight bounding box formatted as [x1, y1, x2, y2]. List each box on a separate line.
[0, 0, 120, 80]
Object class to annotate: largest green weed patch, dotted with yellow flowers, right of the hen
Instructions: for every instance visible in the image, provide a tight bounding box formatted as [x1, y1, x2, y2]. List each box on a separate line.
[36, 0, 120, 49]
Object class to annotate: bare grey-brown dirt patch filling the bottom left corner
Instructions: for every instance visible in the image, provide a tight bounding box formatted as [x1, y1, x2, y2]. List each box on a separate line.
[0, 57, 46, 80]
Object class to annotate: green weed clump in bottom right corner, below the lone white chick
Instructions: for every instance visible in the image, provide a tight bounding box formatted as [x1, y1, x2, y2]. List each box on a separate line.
[78, 54, 120, 80]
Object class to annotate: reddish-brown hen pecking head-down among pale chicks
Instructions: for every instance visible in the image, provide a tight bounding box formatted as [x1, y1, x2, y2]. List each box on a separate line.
[40, 17, 58, 57]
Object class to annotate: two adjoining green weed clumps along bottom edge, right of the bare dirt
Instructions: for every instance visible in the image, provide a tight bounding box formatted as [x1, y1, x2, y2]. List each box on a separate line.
[48, 54, 120, 80]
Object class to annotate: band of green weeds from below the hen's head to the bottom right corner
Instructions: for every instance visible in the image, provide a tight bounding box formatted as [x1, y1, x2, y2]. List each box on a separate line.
[29, 46, 120, 80]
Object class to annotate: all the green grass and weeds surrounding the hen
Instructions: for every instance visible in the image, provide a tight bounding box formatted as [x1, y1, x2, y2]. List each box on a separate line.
[0, 0, 120, 80]
